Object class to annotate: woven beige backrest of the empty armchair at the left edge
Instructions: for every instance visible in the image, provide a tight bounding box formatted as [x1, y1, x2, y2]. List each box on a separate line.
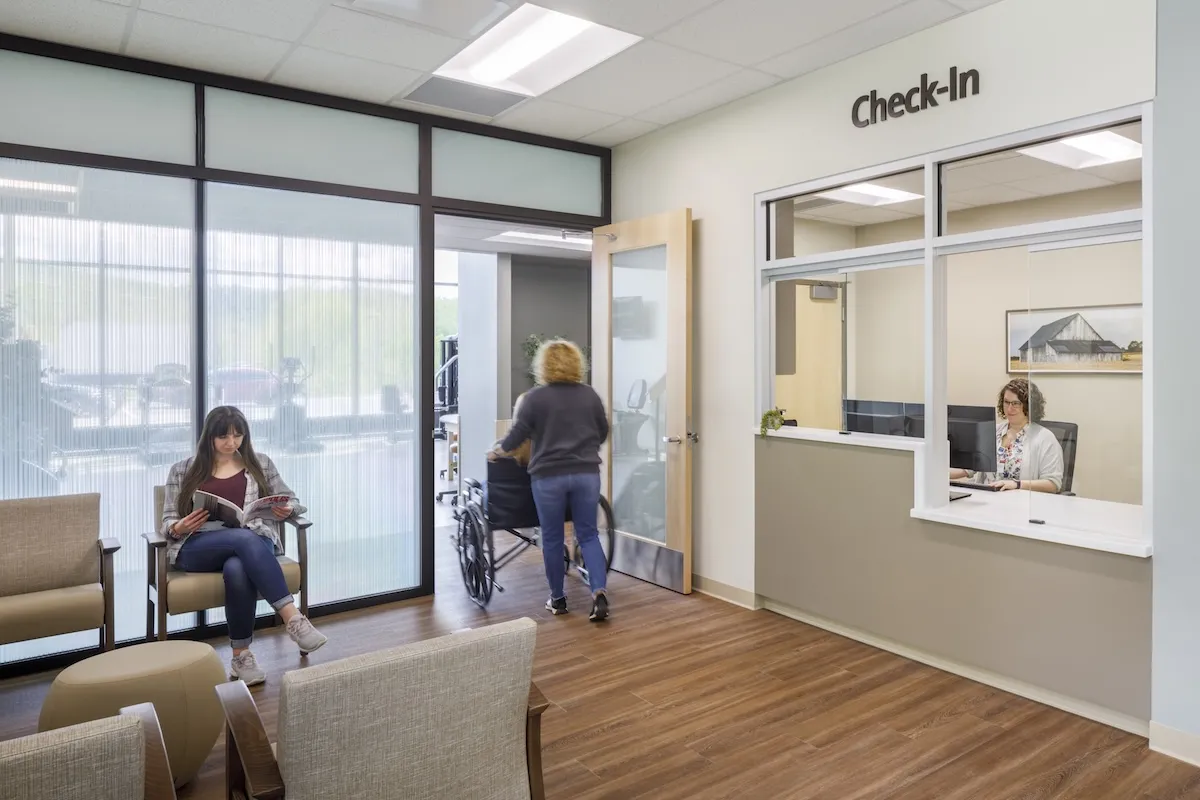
[0, 494, 100, 596]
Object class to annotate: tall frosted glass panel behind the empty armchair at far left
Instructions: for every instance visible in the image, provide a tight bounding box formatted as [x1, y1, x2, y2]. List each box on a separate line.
[0, 158, 194, 662]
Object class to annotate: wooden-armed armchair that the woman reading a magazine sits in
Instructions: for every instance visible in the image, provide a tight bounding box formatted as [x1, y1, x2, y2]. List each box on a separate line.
[142, 486, 312, 642]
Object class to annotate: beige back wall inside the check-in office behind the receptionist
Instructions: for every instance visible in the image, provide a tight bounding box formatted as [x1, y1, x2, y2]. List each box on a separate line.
[847, 185, 1142, 504]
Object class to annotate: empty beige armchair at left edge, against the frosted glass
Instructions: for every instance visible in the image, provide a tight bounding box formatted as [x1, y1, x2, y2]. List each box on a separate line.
[0, 494, 121, 650]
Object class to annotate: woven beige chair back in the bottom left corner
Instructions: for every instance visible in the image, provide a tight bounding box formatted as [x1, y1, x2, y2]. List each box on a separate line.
[0, 716, 145, 800]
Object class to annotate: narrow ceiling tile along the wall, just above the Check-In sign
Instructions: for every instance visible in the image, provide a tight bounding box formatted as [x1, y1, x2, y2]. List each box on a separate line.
[758, 0, 962, 78]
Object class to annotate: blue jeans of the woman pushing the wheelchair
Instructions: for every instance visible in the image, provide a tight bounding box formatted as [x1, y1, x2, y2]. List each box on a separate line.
[533, 473, 608, 600]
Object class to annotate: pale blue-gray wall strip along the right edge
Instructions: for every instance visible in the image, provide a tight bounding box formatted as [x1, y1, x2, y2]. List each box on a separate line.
[1145, 0, 1200, 735]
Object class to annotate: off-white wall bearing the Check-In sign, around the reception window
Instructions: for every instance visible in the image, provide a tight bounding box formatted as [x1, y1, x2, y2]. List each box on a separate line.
[613, 0, 1156, 590]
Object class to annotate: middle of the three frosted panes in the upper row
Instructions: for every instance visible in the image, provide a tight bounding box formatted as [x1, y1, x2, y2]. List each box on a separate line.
[204, 88, 419, 193]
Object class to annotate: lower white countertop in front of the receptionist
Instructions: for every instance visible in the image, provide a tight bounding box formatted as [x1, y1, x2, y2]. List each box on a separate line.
[912, 487, 1153, 558]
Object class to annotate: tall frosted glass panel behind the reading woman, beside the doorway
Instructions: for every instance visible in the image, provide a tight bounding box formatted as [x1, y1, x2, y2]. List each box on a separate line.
[205, 184, 421, 606]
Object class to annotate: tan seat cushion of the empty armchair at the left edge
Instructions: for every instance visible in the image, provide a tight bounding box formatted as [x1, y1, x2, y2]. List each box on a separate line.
[0, 585, 104, 647]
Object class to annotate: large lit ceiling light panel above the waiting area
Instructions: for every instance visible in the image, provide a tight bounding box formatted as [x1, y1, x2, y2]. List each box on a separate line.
[433, 4, 641, 97]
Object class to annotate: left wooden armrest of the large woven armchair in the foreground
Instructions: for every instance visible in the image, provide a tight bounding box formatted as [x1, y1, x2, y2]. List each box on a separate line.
[216, 680, 284, 800]
